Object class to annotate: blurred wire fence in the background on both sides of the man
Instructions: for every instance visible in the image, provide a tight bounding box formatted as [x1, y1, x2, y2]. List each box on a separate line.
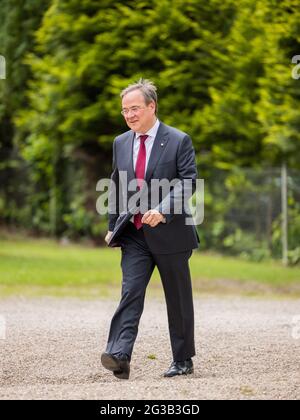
[0, 163, 300, 264]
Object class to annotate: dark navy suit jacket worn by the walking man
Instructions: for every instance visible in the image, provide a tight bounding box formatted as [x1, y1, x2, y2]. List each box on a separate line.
[109, 123, 199, 254]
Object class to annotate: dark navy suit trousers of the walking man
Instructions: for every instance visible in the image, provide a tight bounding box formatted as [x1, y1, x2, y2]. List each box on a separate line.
[106, 222, 195, 361]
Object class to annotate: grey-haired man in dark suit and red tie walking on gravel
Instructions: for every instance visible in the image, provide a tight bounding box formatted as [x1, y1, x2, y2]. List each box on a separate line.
[101, 79, 199, 379]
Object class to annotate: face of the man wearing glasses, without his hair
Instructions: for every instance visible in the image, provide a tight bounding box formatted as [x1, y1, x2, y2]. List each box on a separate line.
[122, 89, 156, 133]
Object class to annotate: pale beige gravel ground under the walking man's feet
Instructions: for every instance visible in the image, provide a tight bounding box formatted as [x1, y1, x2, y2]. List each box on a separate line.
[0, 297, 300, 400]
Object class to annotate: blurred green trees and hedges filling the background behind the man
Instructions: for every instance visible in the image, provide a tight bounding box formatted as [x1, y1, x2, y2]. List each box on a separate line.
[0, 0, 300, 260]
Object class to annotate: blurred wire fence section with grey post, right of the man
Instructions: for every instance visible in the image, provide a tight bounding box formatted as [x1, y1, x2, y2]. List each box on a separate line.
[200, 165, 300, 264]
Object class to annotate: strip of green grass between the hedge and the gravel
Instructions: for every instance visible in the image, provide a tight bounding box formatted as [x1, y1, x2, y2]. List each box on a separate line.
[0, 235, 300, 297]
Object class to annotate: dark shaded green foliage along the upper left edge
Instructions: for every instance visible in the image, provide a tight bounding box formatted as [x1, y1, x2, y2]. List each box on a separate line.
[0, 0, 49, 226]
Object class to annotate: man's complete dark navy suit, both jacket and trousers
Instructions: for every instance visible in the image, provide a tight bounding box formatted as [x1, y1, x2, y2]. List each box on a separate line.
[106, 123, 199, 361]
